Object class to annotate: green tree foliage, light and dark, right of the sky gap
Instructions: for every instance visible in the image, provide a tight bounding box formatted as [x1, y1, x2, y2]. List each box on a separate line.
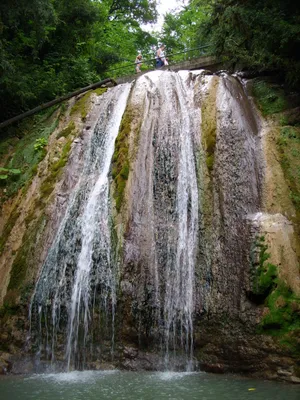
[162, 0, 300, 88]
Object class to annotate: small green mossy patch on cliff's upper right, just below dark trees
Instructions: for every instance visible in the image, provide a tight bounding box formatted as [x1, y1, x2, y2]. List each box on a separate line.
[252, 79, 288, 116]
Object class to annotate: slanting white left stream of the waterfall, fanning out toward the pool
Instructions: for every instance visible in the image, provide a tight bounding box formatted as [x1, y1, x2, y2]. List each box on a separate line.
[31, 84, 130, 369]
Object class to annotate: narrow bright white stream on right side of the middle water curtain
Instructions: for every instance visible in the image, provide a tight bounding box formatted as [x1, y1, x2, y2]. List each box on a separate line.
[159, 75, 198, 368]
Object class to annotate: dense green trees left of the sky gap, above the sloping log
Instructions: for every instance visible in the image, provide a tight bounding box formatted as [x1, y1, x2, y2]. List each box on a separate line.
[0, 0, 157, 121]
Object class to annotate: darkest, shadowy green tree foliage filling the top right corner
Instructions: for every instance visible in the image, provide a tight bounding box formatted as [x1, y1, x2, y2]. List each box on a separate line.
[199, 0, 300, 86]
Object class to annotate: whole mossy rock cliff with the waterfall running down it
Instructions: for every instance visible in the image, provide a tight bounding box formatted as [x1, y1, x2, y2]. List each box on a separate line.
[0, 71, 300, 382]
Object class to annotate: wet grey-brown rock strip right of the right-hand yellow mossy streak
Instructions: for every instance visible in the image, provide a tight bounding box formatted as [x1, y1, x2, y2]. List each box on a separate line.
[209, 76, 263, 314]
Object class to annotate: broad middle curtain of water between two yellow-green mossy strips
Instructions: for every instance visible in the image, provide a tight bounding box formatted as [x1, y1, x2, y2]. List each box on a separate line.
[119, 72, 200, 368]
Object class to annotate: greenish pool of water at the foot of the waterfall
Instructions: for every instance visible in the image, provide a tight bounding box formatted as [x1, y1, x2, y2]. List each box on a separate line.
[0, 371, 300, 400]
